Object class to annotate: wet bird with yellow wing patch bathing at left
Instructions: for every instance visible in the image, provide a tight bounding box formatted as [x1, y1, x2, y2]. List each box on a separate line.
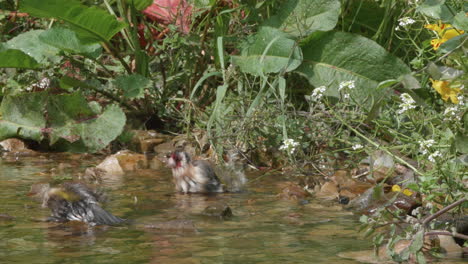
[30, 182, 125, 226]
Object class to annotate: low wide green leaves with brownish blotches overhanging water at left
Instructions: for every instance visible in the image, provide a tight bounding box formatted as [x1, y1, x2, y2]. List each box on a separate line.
[0, 92, 125, 152]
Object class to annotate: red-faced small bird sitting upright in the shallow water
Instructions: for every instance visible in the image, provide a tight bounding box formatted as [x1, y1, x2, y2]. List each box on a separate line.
[167, 150, 223, 193]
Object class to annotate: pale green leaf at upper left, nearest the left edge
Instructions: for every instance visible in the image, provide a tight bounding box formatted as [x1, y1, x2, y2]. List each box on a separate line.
[4, 30, 60, 64]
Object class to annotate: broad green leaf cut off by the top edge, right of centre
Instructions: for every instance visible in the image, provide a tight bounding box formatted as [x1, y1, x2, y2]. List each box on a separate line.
[264, 0, 340, 37]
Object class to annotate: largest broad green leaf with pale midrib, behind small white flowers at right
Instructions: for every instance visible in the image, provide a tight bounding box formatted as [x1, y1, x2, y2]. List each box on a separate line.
[296, 32, 411, 107]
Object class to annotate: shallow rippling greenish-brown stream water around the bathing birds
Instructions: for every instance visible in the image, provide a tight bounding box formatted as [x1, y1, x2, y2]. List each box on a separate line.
[0, 156, 370, 264]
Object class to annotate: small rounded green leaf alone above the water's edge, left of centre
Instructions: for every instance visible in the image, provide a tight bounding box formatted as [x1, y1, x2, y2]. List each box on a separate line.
[115, 74, 150, 99]
